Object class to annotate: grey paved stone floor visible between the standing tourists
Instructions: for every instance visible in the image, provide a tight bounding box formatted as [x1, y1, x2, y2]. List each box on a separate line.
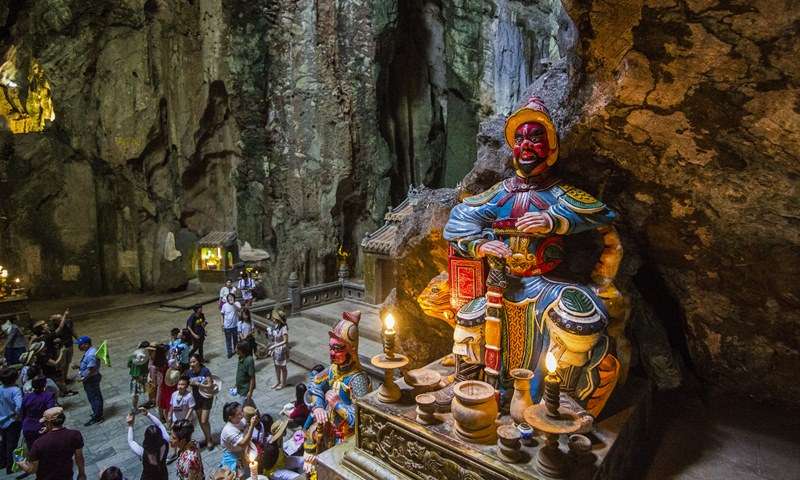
[0, 294, 306, 480]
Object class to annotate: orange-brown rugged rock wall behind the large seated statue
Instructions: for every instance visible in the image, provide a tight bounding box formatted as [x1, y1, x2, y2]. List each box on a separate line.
[564, 0, 800, 403]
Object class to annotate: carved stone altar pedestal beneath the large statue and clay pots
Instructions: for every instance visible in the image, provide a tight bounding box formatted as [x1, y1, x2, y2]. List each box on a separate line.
[318, 356, 651, 480]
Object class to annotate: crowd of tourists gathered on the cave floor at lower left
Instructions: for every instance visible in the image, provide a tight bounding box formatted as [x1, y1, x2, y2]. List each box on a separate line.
[0, 275, 322, 480]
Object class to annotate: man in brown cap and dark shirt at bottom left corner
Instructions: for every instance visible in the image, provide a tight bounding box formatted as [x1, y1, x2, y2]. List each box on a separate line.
[17, 407, 86, 480]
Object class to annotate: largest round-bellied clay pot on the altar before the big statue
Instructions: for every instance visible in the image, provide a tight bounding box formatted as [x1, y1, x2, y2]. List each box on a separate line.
[450, 380, 498, 443]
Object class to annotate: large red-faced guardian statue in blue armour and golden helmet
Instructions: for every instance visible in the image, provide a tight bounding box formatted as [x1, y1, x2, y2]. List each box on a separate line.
[444, 97, 624, 416]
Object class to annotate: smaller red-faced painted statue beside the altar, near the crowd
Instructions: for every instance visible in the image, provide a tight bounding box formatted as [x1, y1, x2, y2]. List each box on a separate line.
[304, 310, 372, 473]
